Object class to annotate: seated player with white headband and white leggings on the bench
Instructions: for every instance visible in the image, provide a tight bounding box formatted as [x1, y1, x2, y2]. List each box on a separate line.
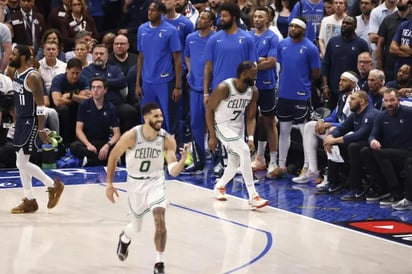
[292, 71, 358, 186]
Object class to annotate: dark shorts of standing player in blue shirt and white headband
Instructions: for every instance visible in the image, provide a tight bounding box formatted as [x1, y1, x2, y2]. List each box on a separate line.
[276, 98, 310, 124]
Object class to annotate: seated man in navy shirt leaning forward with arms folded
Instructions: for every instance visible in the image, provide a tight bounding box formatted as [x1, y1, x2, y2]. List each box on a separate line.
[50, 58, 90, 145]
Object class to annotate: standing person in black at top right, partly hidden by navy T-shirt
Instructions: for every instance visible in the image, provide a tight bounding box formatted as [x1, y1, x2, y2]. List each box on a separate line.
[376, 0, 412, 81]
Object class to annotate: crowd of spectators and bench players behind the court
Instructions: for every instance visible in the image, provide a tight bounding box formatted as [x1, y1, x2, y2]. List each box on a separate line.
[0, 0, 412, 212]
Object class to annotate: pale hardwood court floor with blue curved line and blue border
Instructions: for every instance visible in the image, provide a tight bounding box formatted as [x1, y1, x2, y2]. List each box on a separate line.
[0, 166, 412, 274]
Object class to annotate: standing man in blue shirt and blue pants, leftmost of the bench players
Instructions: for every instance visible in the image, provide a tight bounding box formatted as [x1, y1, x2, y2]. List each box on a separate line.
[135, 1, 182, 139]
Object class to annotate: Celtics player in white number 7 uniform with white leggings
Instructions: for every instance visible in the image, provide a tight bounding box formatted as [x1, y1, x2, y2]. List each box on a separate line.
[206, 61, 269, 209]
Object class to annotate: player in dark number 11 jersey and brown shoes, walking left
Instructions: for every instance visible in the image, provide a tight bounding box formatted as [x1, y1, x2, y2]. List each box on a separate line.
[9, 45, 64, 214]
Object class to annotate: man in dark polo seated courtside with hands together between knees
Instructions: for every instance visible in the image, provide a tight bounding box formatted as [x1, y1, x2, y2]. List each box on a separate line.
[70, 77, 120, 166]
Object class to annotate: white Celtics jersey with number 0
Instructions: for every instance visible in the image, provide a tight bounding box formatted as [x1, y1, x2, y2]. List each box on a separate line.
[126, 125, 168, 179]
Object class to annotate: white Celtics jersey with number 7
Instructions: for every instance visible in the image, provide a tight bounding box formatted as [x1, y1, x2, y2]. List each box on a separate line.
[215, 78, 253, 133]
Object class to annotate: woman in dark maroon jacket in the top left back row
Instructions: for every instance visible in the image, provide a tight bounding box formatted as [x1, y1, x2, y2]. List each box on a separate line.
[60, 0, 98, 51]
